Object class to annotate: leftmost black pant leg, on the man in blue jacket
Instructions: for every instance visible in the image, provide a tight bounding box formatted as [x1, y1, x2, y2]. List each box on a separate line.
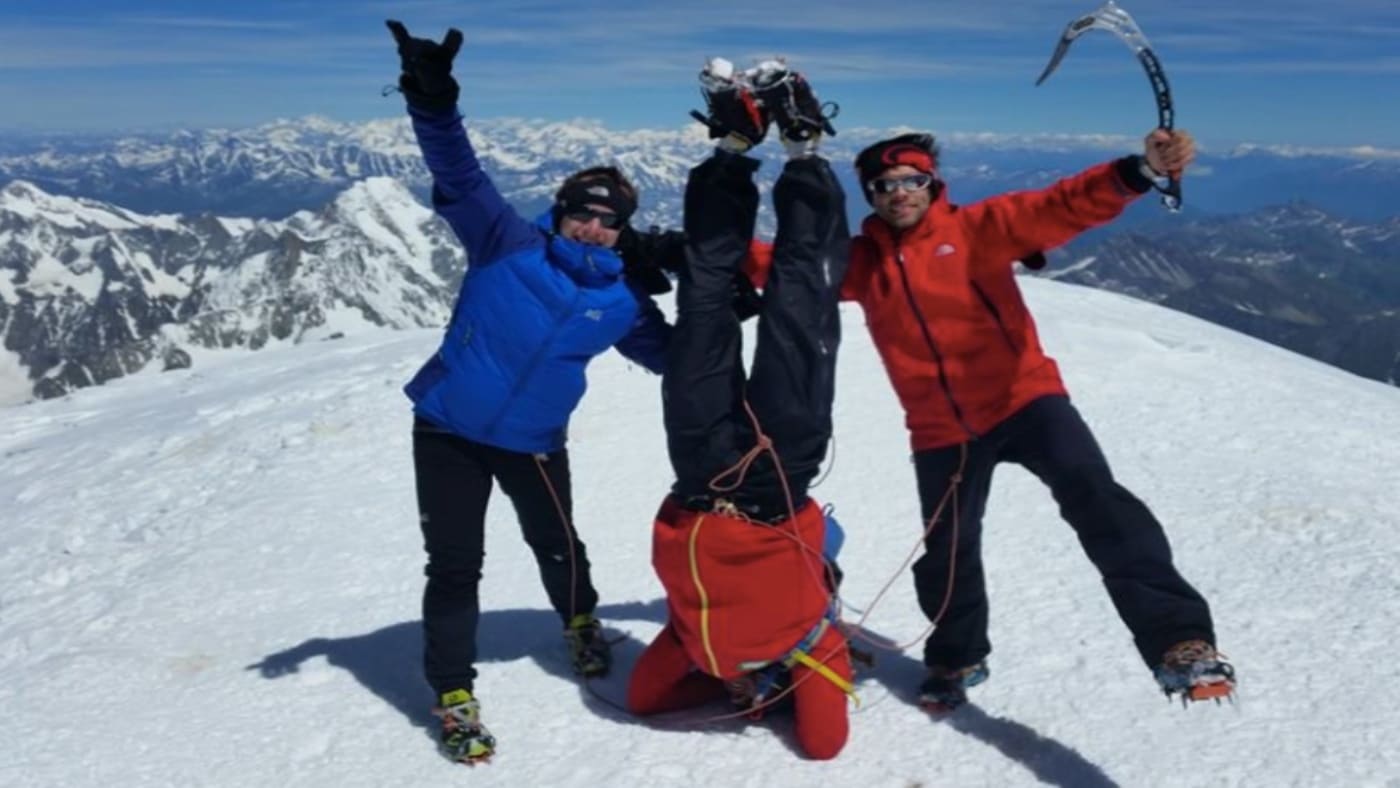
[413, 423, 491, 694]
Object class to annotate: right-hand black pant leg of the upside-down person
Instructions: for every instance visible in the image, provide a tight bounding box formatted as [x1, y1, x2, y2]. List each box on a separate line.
[746, 157, 850, 519]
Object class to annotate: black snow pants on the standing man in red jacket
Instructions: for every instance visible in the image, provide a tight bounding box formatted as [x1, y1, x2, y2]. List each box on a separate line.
[913, 396, 1215, 669]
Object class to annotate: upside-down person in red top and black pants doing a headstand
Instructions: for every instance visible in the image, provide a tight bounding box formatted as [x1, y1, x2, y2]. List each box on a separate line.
[627, 62, 851, 759]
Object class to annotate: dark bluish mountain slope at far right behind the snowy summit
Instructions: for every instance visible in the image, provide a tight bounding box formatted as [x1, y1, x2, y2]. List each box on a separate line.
[1044, 203, 1400, 385]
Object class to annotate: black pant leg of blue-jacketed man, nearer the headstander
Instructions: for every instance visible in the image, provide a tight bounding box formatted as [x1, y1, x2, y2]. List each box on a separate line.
[491, 448, 598, 624]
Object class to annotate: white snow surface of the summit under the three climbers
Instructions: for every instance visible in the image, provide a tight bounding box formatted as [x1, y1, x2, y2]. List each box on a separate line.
[0, 280, 1400, 788]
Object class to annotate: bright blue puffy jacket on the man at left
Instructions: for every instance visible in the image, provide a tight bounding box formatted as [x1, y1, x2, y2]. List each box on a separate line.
[403, 109, 671, 453]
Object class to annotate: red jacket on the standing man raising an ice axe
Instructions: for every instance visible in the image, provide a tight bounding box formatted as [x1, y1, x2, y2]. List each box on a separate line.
[841, 162, 1140, 451]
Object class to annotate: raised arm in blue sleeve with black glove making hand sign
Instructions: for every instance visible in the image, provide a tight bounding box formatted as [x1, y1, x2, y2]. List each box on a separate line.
[385, 20, 543, 266]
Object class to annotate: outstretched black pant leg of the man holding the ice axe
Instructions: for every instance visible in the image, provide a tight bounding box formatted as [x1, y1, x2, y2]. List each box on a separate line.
[1005, 396, 1215, 668]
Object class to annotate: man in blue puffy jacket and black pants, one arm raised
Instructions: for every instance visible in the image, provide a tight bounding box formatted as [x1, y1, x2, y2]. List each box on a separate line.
[388, 21, 671, 760]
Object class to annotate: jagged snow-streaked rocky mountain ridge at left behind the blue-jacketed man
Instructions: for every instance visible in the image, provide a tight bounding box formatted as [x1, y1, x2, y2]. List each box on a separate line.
[0, 178, 465, 400]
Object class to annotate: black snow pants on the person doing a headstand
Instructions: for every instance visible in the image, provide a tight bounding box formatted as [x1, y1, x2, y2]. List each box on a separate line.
[662, 151, 850, 522]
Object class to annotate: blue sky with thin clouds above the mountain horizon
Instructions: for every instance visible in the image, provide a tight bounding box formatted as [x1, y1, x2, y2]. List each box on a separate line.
[0, 0, 1400, 148]
